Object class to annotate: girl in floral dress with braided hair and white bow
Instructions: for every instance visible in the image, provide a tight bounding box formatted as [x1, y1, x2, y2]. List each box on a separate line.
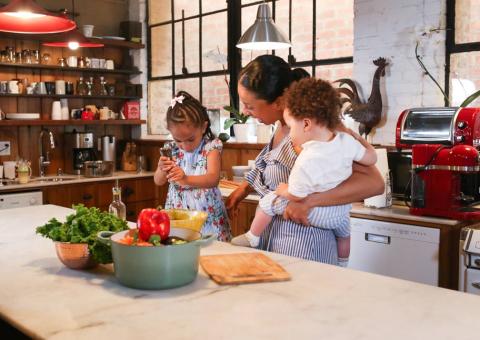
[154, 91, 231, 241]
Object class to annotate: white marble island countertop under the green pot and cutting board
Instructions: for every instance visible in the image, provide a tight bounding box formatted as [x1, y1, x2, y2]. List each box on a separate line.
[0, 206, 480, 340]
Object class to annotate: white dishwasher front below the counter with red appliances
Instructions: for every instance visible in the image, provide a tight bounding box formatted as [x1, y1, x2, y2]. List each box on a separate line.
[348, 217, 440, 286]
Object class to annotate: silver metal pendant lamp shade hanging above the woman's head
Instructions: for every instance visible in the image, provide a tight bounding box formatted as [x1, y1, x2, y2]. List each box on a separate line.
[237, 3, 292, 50]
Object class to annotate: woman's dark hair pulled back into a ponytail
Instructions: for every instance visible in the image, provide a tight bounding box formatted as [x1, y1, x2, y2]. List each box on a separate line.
[239, 54, 310, 103]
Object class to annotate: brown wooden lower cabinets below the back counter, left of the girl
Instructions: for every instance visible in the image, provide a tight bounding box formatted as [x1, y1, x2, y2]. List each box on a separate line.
[43, 177, 168, 222]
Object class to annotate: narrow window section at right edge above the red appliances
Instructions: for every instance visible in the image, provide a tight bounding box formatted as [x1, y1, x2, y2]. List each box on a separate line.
[445, 0, 480, 106]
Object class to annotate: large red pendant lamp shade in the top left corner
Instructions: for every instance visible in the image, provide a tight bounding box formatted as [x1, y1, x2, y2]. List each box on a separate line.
[0, 0, 77, 34]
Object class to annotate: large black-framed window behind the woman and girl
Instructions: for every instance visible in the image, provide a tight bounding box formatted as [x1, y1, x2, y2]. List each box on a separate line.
[148, 0, 353, 135]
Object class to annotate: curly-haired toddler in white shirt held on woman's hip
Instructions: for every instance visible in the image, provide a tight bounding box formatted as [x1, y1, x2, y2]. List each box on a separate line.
[232, 78, 377, 266]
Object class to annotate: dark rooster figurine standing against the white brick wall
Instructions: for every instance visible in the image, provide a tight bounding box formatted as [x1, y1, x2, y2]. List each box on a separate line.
[334, 58, 388, 138]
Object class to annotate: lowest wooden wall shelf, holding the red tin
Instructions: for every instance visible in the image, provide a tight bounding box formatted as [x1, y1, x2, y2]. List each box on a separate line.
[0, 119, 147, 127]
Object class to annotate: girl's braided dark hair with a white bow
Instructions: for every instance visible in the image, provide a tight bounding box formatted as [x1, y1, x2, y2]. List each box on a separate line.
[167, 91, 215, 140]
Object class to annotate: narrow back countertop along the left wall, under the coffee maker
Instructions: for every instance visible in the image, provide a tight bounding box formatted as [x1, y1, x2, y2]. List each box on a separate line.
[0, 171, 154, 193]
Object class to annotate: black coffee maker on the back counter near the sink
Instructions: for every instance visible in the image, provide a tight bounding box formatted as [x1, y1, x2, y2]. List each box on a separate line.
[65, 130, 97, 175]
